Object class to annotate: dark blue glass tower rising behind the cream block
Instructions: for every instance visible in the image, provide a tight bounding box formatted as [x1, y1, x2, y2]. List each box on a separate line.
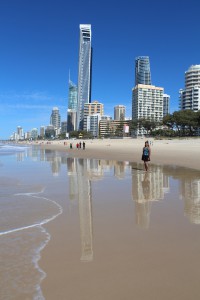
[135, 56, 151, 86]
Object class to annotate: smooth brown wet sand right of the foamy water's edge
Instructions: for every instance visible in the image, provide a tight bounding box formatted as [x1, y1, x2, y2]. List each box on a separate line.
[40, 160, 200, 300]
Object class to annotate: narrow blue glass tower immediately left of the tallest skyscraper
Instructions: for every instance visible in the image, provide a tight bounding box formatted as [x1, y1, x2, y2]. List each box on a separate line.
[67, 80, 78, 132]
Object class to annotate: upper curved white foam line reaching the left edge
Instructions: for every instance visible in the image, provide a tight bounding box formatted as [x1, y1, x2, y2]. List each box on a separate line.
[0, 190, 63, 236]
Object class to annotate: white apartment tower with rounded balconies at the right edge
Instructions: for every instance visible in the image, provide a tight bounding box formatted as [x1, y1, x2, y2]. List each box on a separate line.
[179, 65, 200, 111]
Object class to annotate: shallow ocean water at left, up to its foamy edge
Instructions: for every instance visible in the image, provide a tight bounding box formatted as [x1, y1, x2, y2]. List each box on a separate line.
[0, 145, 62, 300]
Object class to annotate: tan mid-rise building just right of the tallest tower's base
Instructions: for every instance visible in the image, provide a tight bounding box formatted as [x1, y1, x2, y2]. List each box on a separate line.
[83, 101, 104, 130]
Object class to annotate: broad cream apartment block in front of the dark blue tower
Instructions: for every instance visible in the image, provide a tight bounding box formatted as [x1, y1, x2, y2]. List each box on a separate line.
[132, 84, 164, 135]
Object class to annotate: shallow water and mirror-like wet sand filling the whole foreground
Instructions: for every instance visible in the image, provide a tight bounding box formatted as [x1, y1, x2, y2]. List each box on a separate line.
[0, 147, 200, 300]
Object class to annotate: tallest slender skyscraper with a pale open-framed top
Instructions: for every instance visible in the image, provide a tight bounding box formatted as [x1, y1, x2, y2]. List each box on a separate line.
[77, 24, 92, 130]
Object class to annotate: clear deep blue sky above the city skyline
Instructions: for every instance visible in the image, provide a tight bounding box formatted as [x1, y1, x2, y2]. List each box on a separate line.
[0, 0, 200, 139]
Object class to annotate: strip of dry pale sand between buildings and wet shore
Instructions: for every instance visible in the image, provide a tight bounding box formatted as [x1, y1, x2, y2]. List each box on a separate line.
[20, 138, 200, 170]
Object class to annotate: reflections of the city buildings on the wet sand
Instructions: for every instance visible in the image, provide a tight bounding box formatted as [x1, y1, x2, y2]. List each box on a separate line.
[17, 147, 200, 261]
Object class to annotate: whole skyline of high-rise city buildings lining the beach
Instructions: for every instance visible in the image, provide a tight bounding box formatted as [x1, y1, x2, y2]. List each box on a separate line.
[11, 24, 200, 140]
